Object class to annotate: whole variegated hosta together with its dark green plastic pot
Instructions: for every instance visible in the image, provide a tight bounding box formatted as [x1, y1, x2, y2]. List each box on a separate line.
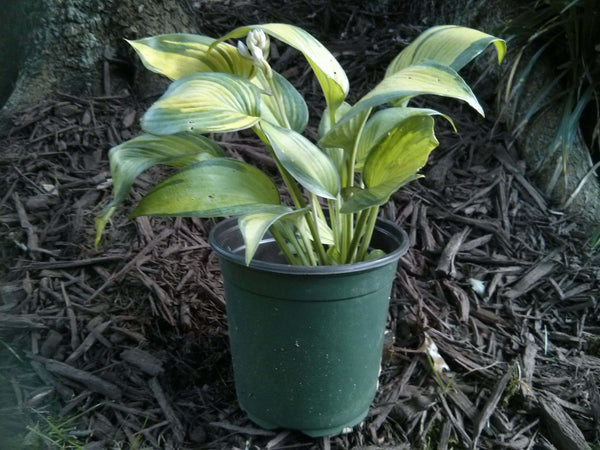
[96, 23, 505, 436]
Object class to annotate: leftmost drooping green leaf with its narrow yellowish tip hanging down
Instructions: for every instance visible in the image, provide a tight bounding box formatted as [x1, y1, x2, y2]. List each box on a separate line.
[96, 133, 224, 245]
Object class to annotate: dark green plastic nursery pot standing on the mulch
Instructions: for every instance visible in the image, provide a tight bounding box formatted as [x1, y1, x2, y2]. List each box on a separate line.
[210, 218, 408, 436]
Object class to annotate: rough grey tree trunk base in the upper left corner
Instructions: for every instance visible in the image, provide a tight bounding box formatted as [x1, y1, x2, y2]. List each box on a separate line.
[0, 0, 195, 109]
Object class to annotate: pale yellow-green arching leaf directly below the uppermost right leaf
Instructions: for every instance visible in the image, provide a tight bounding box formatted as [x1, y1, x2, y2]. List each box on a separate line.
[338, 61, 484, 126]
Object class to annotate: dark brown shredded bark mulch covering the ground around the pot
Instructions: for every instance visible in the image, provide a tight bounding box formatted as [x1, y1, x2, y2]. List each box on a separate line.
[0, 4, 600, 449]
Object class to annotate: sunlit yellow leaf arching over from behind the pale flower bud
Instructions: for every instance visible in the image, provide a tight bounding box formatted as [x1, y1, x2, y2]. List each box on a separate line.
[218, 23, 349, 111]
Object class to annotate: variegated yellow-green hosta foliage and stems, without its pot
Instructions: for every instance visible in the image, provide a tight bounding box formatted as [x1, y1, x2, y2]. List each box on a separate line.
[96, 23, 506, 265]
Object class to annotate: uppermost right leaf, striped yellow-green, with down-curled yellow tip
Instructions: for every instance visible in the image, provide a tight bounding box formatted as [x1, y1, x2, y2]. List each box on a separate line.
[386, 25, 506, 77]
